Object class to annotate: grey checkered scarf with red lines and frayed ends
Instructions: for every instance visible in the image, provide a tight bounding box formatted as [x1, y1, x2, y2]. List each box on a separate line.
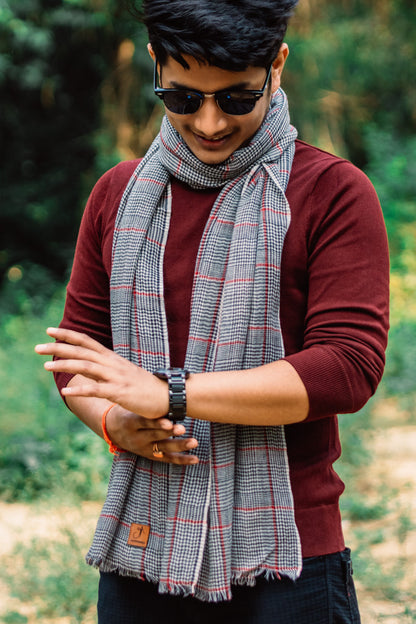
[87, 90, 301, 601]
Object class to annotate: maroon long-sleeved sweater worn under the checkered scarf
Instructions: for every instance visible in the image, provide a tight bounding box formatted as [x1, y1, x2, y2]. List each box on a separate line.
[56, 141, 389, 557]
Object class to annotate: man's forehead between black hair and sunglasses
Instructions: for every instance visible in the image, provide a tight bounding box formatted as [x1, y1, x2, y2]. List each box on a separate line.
[162, 55, 265, 93]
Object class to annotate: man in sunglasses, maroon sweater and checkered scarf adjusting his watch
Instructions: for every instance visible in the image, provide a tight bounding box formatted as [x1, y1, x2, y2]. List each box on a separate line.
[37, 0, 388, 624]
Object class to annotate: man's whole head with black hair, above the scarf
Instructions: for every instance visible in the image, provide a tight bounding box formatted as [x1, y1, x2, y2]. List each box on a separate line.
[133, 0, 297, 164]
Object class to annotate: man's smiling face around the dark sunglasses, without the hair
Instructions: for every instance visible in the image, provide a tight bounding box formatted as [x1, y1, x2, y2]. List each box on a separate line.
[149, 44, 288, 165]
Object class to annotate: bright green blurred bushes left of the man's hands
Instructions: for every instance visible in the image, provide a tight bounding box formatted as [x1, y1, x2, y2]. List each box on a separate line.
[0, 289, 111, 502]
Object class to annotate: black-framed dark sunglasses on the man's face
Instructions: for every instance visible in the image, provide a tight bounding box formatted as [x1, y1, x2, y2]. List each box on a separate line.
[153, 63, 272, 115]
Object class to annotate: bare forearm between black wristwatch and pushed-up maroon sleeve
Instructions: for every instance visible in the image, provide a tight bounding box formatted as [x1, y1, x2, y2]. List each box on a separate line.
[186, 360, 309, 426]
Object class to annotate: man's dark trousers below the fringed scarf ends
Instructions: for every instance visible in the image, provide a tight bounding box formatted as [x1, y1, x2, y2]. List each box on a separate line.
[98, 549, 360, 624]
